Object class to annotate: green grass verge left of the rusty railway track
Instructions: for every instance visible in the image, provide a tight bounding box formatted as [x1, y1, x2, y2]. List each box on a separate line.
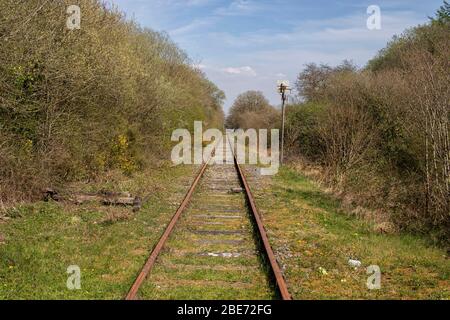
[0, 166, 195, 299]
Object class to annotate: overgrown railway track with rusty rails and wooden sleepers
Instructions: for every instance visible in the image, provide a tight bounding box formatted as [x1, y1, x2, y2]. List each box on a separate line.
[126, 135, 291, 300]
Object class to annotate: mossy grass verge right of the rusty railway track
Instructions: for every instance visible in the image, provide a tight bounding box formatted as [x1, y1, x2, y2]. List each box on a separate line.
[248, 168, 450, 299]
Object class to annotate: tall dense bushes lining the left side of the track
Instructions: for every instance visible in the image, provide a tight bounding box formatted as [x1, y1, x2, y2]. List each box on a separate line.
[0, 0, 224, 204]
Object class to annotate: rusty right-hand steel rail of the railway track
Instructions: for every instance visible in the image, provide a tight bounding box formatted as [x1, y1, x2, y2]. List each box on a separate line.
[227, 137, 292, 300]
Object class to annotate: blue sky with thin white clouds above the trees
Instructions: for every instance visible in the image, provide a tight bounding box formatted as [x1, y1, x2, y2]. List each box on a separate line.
[110, 0, 442, 109]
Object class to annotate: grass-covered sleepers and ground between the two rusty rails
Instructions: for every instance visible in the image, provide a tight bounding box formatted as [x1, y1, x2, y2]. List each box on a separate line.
[134, 167, 275, 300]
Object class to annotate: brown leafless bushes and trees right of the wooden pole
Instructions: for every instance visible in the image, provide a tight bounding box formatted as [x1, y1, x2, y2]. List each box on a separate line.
[287, 2, 450, 241]
